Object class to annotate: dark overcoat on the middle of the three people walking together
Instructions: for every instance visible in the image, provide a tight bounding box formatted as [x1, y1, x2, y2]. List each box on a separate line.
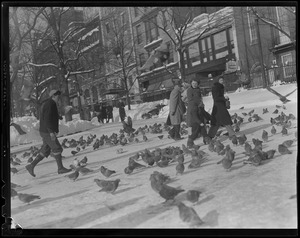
[186, 86, 202, 127]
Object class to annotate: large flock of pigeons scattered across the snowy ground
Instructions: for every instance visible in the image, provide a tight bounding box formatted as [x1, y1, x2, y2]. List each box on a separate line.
[11, 105, 297, 227]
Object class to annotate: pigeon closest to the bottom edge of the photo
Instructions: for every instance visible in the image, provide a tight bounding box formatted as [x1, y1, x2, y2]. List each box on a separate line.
[176, 202, 204, 227]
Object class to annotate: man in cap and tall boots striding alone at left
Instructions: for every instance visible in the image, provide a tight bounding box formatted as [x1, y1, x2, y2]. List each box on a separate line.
[25, 90, 72, 177]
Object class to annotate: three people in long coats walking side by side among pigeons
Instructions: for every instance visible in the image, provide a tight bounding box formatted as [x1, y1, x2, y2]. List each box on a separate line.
[169, 76, 235, 148]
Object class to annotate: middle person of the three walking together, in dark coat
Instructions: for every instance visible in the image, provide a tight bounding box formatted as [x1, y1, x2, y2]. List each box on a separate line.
[187, 78, 210, 148]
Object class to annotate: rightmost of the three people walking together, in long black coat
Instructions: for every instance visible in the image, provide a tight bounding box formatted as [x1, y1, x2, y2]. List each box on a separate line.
[208, 76, 235, 138]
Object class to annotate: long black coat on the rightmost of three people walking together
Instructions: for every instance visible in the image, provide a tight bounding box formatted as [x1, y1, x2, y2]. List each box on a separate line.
[211, 82, 233, 126]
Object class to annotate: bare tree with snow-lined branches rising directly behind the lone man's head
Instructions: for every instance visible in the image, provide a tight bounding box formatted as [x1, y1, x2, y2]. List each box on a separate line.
[28, 7, 99, 121]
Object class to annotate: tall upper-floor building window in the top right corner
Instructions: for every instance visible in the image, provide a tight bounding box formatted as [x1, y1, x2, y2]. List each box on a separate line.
[276, 7, 291, 44]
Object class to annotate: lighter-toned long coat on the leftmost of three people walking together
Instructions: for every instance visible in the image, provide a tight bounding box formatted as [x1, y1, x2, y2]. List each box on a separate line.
[169, 85, 184, 125]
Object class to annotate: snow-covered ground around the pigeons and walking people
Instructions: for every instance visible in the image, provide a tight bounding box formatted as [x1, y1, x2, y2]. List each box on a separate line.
[10, 84, 298, 228]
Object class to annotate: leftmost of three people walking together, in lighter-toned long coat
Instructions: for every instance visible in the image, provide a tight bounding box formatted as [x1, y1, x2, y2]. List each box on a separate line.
[169, 79, 185, 140]
